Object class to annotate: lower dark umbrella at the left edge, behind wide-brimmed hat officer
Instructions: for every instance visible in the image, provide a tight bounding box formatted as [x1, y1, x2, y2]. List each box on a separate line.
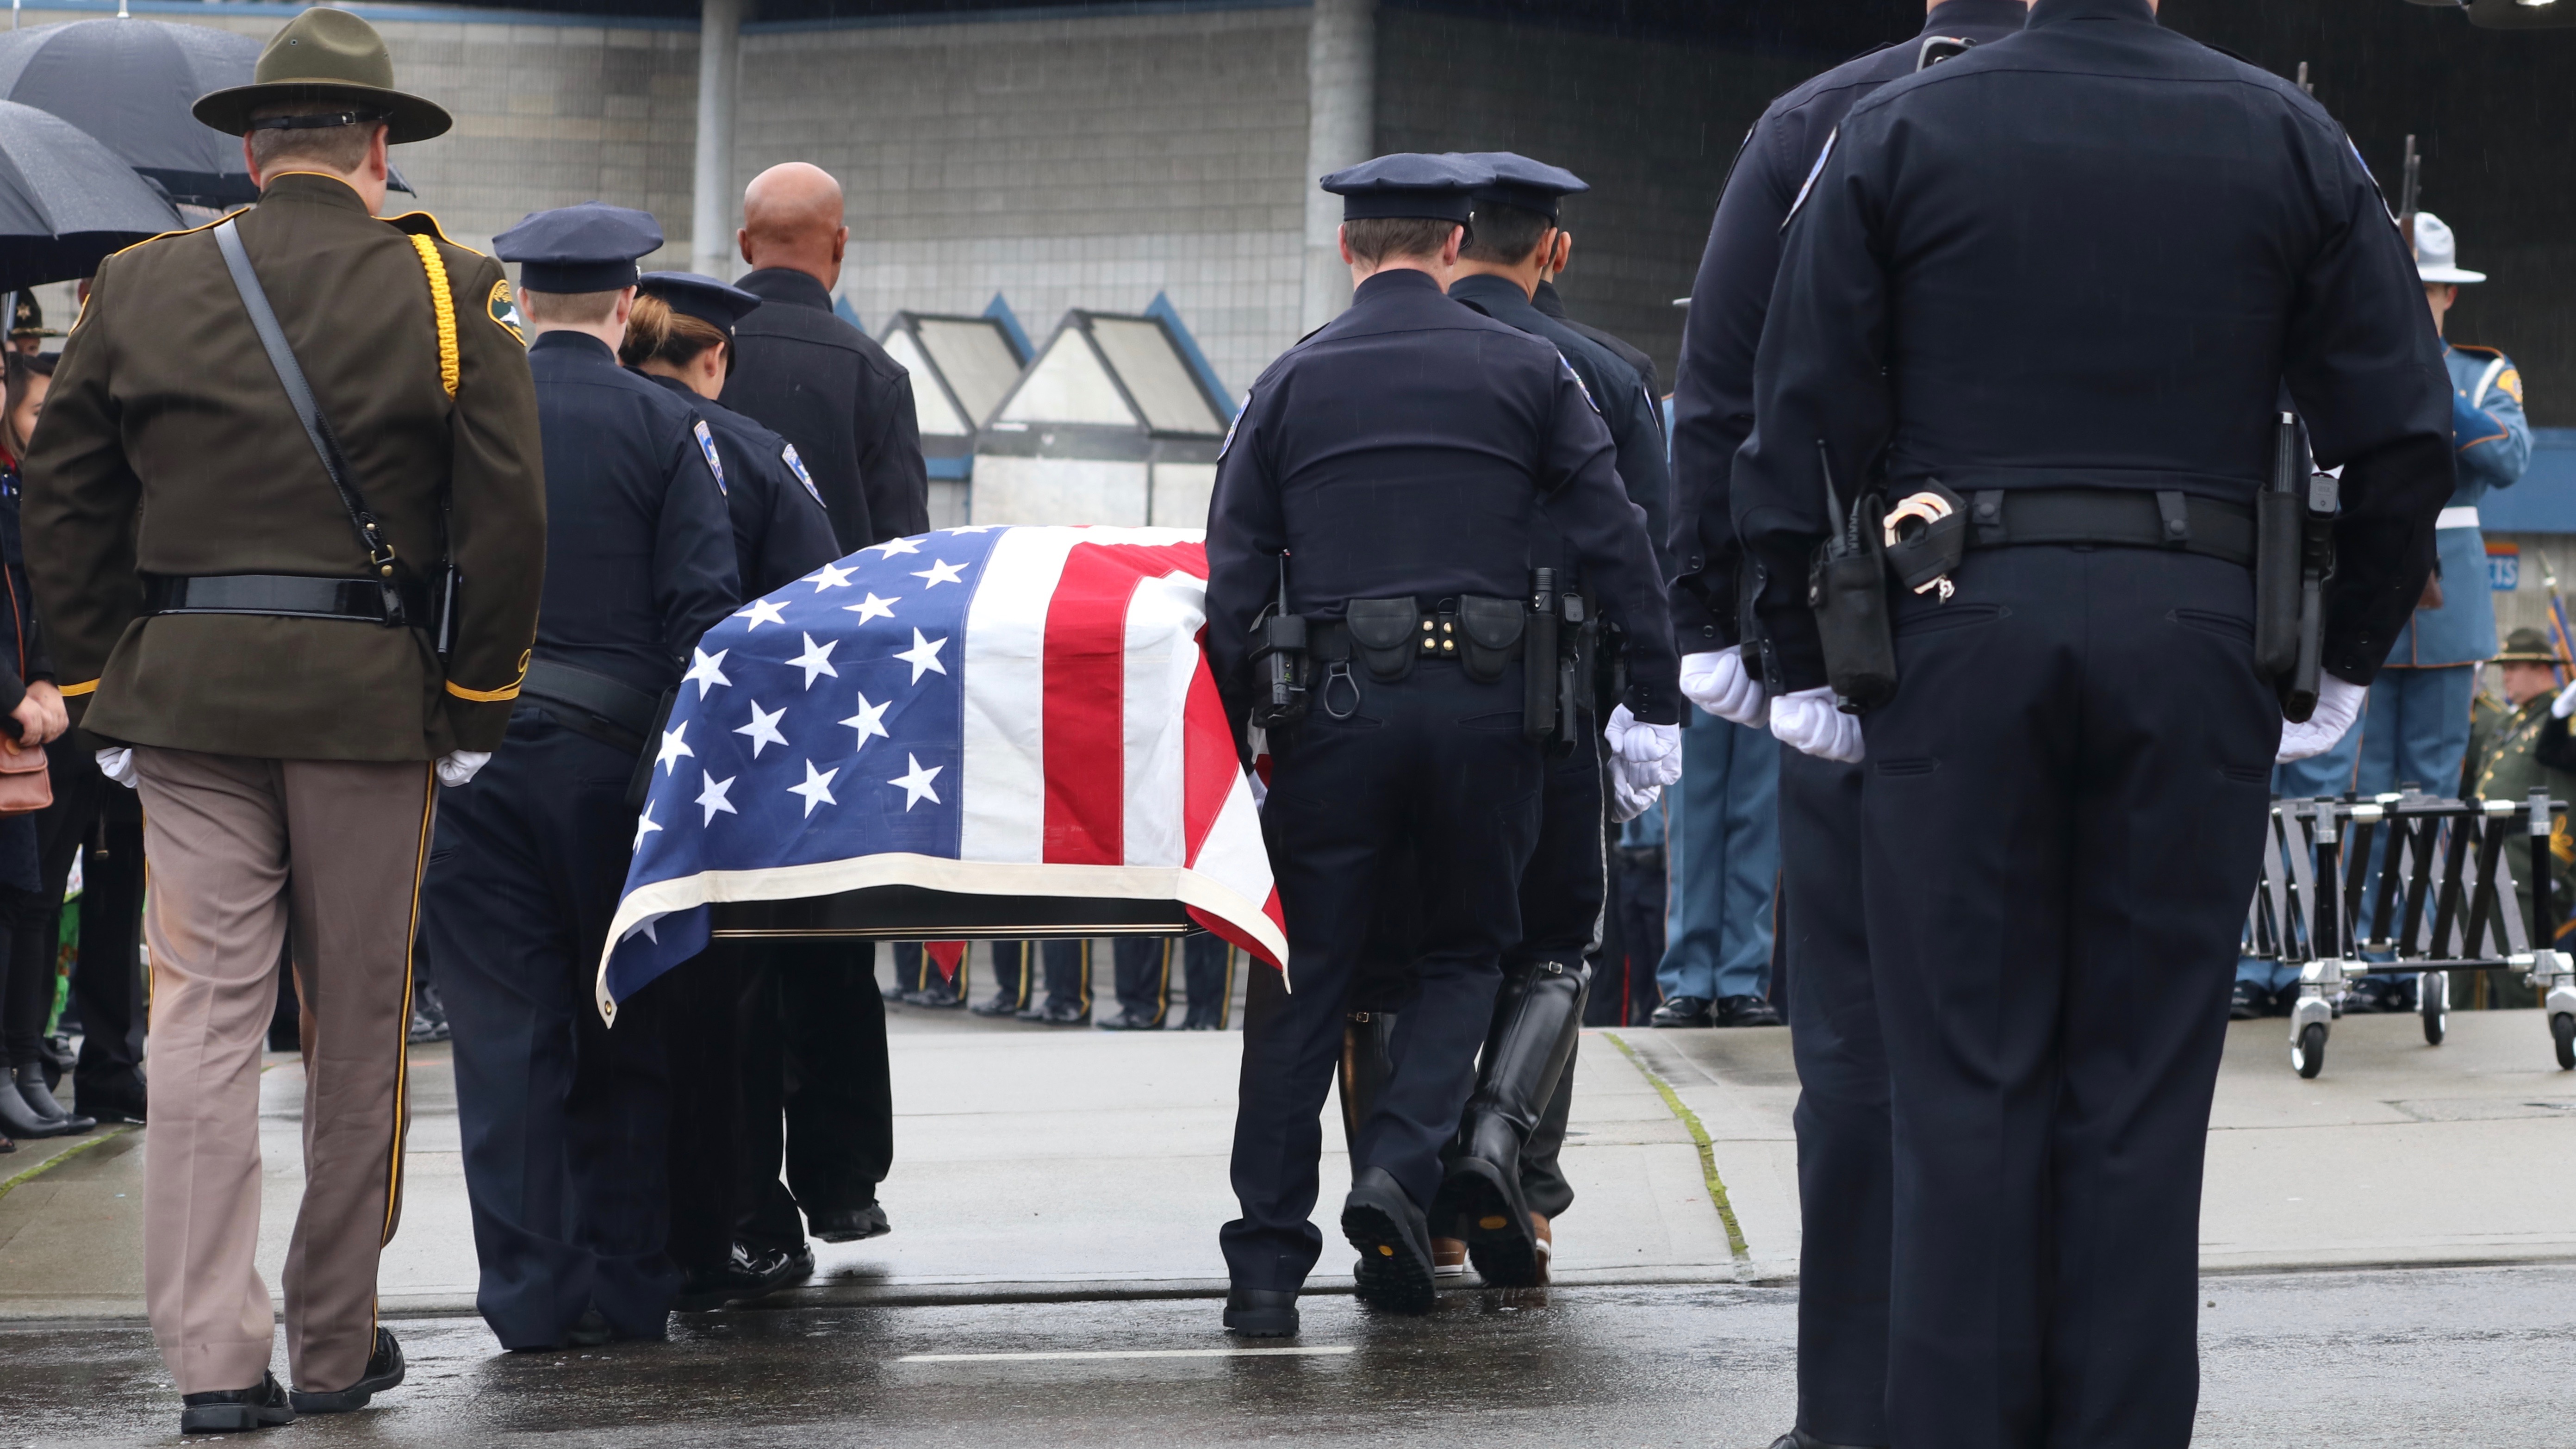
[0, 100, 180, 288]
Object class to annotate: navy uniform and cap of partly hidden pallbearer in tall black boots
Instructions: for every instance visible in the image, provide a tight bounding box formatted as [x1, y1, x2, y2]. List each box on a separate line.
[1435, 152, 1672, 1282]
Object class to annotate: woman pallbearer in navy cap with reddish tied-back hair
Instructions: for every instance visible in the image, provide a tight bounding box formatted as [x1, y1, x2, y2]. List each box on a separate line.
[618, 273, 840, 1310]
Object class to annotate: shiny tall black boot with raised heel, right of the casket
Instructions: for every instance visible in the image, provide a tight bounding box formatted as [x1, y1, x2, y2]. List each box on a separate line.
[1435, 958, 1592, 1287]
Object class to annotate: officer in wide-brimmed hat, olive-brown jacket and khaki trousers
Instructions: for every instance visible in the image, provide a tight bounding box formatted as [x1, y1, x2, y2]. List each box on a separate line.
[26, 8, 546, 1434]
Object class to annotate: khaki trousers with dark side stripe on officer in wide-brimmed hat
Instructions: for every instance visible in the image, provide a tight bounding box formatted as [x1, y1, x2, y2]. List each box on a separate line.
[134, 746, 438, 1393]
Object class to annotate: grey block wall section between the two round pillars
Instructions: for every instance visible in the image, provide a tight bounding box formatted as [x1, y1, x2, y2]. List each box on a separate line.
[732, 5, 1309, 389]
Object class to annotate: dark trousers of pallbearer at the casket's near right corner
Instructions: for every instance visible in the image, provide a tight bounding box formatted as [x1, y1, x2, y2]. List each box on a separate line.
[1219, 664, 1546, 1289]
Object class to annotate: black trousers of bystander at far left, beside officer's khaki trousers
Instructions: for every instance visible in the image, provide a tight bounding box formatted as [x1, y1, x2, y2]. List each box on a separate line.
[36, 736, 144, 1109]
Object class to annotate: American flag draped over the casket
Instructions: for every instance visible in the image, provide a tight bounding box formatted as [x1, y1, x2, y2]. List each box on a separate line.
[597, 525, 1288, 1017]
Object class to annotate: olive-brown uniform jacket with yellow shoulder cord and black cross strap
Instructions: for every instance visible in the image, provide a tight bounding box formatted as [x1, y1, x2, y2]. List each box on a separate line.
[26, 173, 546, 759]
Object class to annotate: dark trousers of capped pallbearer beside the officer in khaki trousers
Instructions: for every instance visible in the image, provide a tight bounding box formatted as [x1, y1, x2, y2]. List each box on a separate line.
[425, 705, 680, 1349]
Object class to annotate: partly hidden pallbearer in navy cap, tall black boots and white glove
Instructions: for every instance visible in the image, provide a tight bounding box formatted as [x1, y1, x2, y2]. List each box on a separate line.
[1422, 152, 1682, 1287]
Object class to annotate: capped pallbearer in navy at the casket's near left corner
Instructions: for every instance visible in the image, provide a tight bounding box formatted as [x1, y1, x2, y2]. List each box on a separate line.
[430, 201, 737, 1349]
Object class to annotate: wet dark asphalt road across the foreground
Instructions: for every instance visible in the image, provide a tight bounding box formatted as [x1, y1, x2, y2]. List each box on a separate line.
[0, 1266, 2576, 1449]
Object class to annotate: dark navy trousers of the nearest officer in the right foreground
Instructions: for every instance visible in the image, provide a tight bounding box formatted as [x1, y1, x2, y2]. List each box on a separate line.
[1862, 546, 2280, 1449]
